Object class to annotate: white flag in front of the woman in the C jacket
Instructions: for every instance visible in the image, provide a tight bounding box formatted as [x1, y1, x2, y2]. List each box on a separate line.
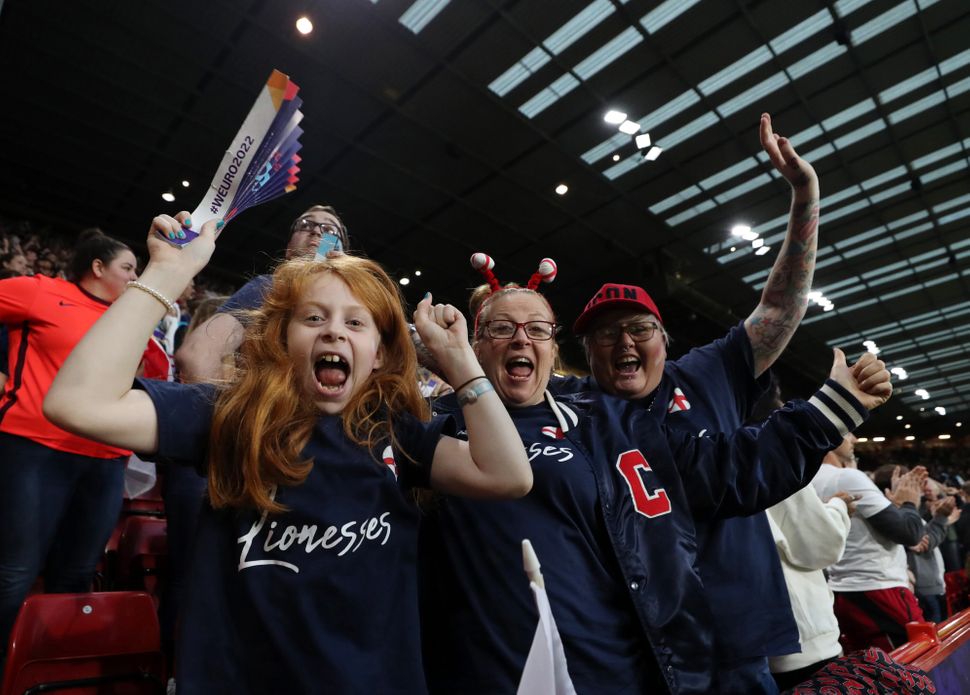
[518, 540, 576, 695]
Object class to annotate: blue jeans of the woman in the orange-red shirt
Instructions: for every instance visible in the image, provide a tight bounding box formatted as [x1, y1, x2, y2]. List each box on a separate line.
[0, 433, 125, 654]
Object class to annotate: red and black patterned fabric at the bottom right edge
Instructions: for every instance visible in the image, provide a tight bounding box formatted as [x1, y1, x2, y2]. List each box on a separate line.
[786, 647, 936, 695]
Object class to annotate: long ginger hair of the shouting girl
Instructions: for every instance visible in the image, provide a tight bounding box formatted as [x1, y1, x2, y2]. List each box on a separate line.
[209, 255, 429, 512]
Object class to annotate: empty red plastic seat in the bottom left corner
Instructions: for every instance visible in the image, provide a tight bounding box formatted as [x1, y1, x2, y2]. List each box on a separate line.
[0, 591, 165, 695]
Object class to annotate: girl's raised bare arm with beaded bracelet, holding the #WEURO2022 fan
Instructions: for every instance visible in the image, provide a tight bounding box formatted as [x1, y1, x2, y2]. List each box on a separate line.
[44, 218, 216, 453]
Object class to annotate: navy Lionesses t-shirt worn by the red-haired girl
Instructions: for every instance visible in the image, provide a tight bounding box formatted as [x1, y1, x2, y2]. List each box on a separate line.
[139, 381, 452, 695]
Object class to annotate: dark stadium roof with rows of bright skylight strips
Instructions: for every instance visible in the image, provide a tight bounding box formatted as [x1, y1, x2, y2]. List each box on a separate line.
[0, 0, 970, 437]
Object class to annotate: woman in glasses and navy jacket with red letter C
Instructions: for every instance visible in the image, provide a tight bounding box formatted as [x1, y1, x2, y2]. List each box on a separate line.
[421, 254, 891, 694]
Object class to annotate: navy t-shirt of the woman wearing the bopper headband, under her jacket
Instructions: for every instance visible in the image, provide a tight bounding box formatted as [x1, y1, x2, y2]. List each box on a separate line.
[421, 402, 661, 693]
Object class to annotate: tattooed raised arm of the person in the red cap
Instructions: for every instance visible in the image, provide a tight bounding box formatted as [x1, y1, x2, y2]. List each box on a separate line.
[744, 114, 819, 376]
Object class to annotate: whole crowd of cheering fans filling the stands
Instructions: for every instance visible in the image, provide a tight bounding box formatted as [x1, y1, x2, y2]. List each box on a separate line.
[0, 114, 952, 695]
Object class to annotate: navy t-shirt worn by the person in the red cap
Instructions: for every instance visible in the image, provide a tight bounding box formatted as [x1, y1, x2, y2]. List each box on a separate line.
[549, 323, 801, 662]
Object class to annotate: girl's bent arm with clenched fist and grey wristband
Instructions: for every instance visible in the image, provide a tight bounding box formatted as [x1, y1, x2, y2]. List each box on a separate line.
[414, 295, 532, 497]
